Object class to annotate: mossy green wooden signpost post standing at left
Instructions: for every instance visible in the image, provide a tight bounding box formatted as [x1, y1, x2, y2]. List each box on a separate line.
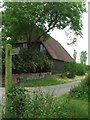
[5, 44, 12, 116]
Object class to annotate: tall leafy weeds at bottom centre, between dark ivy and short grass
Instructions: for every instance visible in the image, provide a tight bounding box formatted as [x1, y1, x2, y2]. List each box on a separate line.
[25, 91, 64, 118]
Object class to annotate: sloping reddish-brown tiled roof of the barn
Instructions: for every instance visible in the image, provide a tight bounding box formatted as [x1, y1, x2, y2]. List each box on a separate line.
[42, 37, 73, 62]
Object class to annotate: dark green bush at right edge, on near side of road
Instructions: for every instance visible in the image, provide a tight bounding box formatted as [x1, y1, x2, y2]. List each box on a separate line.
[70, 73, 90, 99]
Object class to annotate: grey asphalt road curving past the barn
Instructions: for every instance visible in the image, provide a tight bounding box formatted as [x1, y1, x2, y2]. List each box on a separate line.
[0, 81, 80, 101]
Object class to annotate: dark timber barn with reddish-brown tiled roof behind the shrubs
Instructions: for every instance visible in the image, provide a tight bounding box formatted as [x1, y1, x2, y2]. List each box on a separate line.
[14, 37, 73, 73]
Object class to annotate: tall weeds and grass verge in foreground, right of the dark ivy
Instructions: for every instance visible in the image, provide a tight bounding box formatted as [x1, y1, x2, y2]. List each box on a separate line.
[0, 89, 88, 119]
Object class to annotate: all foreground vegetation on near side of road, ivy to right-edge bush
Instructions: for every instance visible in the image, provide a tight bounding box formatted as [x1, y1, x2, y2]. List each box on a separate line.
[3, 73, 90, 119]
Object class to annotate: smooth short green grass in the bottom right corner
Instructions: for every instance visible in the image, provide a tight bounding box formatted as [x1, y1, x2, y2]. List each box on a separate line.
[59, 95, 88, 118]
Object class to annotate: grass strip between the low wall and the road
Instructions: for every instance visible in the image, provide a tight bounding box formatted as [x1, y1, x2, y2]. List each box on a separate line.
[20, 74, 85, 87]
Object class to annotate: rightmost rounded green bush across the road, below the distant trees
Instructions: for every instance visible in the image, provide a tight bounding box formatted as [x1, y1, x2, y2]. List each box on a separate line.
[76, 64, 86, 75]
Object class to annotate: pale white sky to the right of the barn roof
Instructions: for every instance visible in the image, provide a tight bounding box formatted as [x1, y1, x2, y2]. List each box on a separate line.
[50, 5, 88, 64]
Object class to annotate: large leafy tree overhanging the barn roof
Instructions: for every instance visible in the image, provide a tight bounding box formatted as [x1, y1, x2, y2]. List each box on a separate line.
[2, 2, 85, 42]
